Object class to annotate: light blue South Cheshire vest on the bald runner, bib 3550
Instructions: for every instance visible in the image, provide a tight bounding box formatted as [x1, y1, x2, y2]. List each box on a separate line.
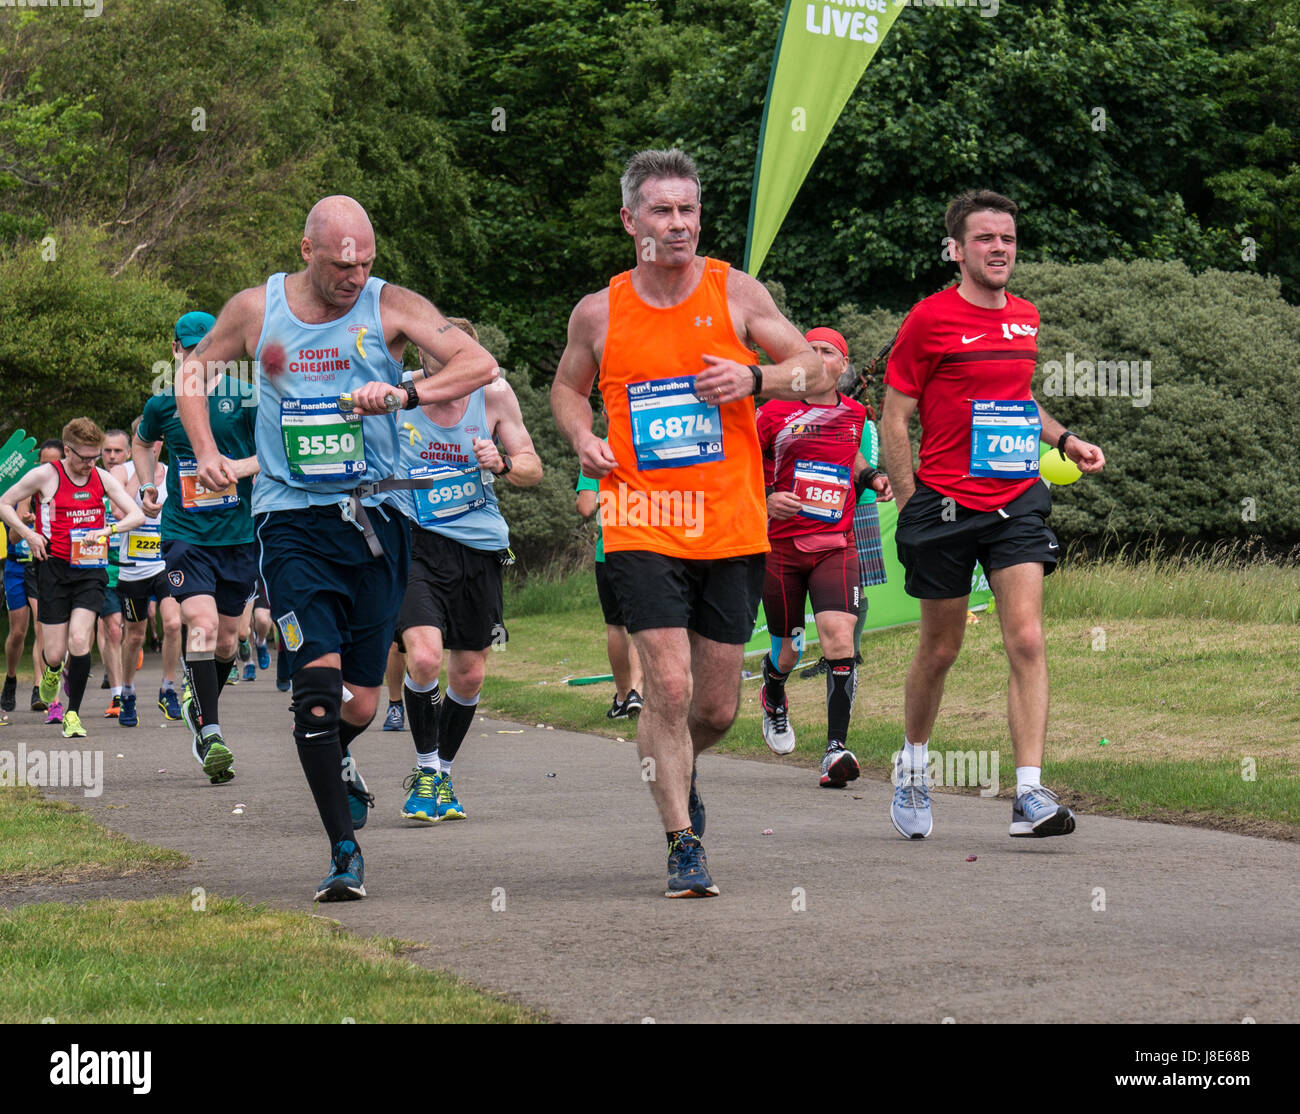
[252, 273, 407, 515]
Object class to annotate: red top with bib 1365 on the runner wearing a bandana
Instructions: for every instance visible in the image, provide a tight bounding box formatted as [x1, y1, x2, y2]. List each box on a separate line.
[758, 394, 867, 539]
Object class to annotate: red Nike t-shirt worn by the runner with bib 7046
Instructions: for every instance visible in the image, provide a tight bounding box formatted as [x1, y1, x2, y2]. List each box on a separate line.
[885, 286, 1039, 511]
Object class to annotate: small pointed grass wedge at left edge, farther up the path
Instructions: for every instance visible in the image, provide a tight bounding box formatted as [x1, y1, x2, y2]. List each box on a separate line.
[0, 786, 189, 883]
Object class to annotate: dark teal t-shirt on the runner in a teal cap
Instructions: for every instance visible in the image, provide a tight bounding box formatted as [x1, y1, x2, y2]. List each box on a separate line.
[137, 377, 257, 546]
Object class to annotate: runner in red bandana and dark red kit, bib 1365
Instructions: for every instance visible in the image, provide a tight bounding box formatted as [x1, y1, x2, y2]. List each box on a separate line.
[758, 329, 892, 789]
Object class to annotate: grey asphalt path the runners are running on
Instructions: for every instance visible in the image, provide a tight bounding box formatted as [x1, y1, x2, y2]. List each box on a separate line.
[0, 659, 1300, 1023]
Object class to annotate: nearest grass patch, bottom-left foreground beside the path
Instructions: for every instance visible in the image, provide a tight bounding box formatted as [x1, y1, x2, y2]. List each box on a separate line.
[0, 896, 540, 1024]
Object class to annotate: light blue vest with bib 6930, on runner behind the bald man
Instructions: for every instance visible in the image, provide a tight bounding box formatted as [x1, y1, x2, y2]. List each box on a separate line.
[395, 387, 510, 551]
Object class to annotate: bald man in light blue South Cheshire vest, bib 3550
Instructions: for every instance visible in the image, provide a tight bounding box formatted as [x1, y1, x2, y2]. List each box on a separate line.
[177, 196, 498, 901]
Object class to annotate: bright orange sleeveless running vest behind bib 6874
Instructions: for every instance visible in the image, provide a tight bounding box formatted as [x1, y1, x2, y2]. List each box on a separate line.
[598, 259, 770, 560]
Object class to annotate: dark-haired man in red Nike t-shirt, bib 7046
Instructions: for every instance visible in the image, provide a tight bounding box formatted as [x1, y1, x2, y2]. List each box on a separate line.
[881, 190, 1105, 840]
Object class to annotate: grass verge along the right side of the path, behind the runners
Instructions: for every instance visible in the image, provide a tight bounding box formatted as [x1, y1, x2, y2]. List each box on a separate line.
[482, 558, 1300, 835]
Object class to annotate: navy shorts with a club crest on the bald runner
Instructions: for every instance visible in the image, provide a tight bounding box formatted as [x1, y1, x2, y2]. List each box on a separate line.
[256, 504, 411, 688]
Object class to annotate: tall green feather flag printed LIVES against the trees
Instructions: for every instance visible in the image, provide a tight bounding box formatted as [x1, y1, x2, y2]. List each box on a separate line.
[745, 0, 905, 274]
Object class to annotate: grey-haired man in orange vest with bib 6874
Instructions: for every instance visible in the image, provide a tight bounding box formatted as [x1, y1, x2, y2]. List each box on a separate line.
[551, 151, 835, 897]
